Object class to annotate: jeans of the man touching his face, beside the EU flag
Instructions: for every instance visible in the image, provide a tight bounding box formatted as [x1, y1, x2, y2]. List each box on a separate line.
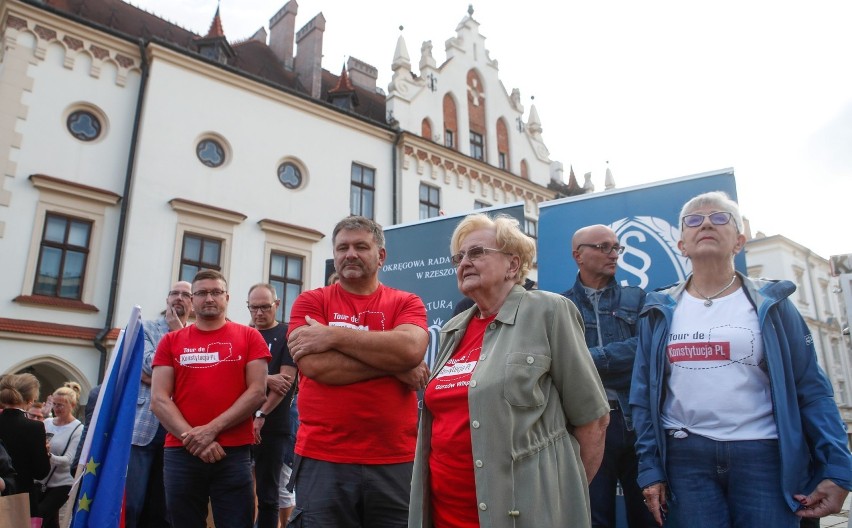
[124, 425, 171, 528]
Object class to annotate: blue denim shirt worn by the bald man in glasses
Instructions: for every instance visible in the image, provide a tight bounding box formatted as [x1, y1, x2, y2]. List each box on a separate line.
[562, 273, 645, 430]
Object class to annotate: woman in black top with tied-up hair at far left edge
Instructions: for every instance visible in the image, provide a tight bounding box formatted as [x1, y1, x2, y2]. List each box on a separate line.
[0, 374, 50, 516]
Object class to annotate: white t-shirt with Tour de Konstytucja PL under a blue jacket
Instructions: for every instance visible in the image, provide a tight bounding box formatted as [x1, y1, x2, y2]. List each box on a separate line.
[662, 289, 778, 441]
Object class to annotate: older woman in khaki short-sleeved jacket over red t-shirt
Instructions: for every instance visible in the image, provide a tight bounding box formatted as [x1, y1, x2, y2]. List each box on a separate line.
[408, 214, 609, 528]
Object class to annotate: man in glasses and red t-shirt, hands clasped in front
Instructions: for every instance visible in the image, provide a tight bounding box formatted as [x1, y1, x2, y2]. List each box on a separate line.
[151, 270, 271, 528]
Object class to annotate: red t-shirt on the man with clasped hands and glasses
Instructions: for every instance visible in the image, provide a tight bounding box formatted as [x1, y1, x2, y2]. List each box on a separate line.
[152, 322, 272, 447]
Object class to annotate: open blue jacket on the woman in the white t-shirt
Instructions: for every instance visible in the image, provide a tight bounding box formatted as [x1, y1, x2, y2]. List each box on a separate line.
[630, 275, 852, 511]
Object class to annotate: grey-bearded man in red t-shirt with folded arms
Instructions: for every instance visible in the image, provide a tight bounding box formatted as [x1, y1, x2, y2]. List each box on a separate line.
[288, 216, 429, 528]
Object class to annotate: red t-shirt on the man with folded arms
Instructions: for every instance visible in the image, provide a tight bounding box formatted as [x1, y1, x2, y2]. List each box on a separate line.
[288, 284, 426, 464]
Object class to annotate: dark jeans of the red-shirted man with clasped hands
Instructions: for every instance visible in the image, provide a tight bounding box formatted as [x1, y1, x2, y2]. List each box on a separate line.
[163, 446, 254, 528]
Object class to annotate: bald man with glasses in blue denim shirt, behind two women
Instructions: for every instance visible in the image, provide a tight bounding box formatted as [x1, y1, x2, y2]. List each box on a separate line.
[562, 225, 656, 528]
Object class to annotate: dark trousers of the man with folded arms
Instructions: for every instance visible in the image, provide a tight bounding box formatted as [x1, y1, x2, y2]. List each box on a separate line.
[287, 456, 414, 528]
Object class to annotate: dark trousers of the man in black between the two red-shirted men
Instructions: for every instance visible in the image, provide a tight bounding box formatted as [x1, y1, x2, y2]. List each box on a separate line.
[253, 431, 290, 528]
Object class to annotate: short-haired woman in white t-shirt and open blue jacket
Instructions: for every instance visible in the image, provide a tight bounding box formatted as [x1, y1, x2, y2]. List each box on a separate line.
[630, 192, 852, 528]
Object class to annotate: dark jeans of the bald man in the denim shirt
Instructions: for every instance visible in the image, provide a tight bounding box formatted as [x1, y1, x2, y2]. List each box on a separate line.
[589, 409, 657, 528]
